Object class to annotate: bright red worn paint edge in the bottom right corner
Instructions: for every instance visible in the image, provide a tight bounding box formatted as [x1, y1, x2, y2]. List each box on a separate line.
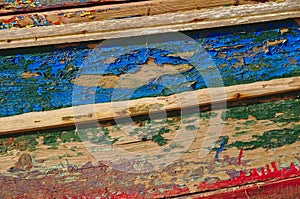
[152, 162, 300, 199]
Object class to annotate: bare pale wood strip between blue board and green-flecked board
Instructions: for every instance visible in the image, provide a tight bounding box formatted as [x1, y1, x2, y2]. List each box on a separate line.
[0, 77, 300, 135]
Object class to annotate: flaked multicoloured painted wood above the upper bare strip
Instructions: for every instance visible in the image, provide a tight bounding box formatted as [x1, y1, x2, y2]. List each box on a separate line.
[0, 0, 277, 30]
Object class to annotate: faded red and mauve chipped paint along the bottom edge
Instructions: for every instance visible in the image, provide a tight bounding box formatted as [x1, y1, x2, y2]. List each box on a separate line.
[0, 159, 300, 198]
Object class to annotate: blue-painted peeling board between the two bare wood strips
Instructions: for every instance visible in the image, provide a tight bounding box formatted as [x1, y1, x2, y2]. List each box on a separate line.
[0, 20, 300, 117]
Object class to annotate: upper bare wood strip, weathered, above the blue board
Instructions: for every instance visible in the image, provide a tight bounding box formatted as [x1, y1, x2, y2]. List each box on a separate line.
[0, 0, 300, 49]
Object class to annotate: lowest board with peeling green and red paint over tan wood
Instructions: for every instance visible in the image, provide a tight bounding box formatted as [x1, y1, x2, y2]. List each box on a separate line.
[0, 99, 300, 198]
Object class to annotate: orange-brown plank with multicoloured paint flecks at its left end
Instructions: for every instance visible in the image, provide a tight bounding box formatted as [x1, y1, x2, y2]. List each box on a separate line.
[0, 0, 276, 29]
